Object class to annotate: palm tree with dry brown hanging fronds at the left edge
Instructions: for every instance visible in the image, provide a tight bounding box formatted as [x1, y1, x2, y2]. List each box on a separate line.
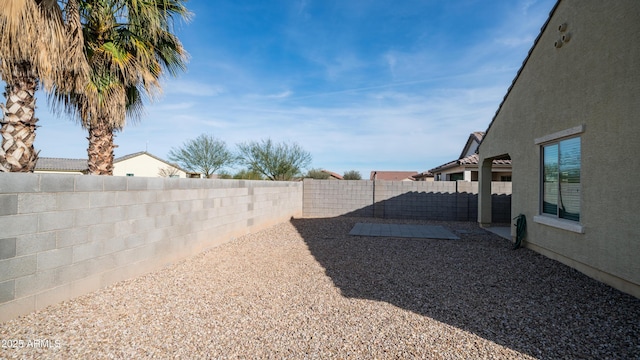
[0, 0, 88, 172]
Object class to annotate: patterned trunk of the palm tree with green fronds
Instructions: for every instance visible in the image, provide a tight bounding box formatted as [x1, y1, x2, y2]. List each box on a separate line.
[87, 120, 116, 175]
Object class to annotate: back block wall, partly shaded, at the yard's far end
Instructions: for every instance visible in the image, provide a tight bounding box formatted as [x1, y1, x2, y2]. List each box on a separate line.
[303, 179, 511, 223]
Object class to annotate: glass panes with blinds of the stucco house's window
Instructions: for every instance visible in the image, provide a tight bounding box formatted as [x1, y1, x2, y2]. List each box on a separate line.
[541, 137, 581, 221]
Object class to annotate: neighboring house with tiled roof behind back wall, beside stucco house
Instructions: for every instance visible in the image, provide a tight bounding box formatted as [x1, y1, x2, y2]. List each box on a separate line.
[428, 131, 511, 181]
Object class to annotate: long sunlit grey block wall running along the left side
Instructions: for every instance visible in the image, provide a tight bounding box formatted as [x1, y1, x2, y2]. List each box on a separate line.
[0, 173, 302, 321]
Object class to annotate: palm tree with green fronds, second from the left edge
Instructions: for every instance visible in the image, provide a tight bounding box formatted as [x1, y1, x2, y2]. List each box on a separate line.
[65, 0, 189, 175]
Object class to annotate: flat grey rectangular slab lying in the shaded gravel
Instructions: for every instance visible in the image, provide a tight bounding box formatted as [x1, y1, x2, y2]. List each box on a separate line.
[349, 223, 460, 240]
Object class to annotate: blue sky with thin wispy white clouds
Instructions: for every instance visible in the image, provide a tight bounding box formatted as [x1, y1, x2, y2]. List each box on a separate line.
[23, 0, 555, 178]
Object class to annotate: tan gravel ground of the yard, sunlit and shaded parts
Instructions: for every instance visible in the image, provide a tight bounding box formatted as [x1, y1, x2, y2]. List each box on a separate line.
[0, 218, 640, 359]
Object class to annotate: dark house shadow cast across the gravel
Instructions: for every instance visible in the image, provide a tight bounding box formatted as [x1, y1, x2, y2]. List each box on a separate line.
[291, 218, 640, 359]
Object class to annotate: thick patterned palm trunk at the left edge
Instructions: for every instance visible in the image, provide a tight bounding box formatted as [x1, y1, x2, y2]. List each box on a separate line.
[0, 62, 38, 172]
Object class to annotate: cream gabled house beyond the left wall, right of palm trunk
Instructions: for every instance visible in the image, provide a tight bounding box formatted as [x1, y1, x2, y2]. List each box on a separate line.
[113, 151, 193, 178]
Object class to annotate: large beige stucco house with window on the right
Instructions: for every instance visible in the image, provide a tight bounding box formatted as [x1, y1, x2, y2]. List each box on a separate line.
[478, 0, 640, 297]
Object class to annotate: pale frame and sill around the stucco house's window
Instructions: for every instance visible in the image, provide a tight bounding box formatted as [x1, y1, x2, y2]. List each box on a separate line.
[533, 125, 585, 234]
